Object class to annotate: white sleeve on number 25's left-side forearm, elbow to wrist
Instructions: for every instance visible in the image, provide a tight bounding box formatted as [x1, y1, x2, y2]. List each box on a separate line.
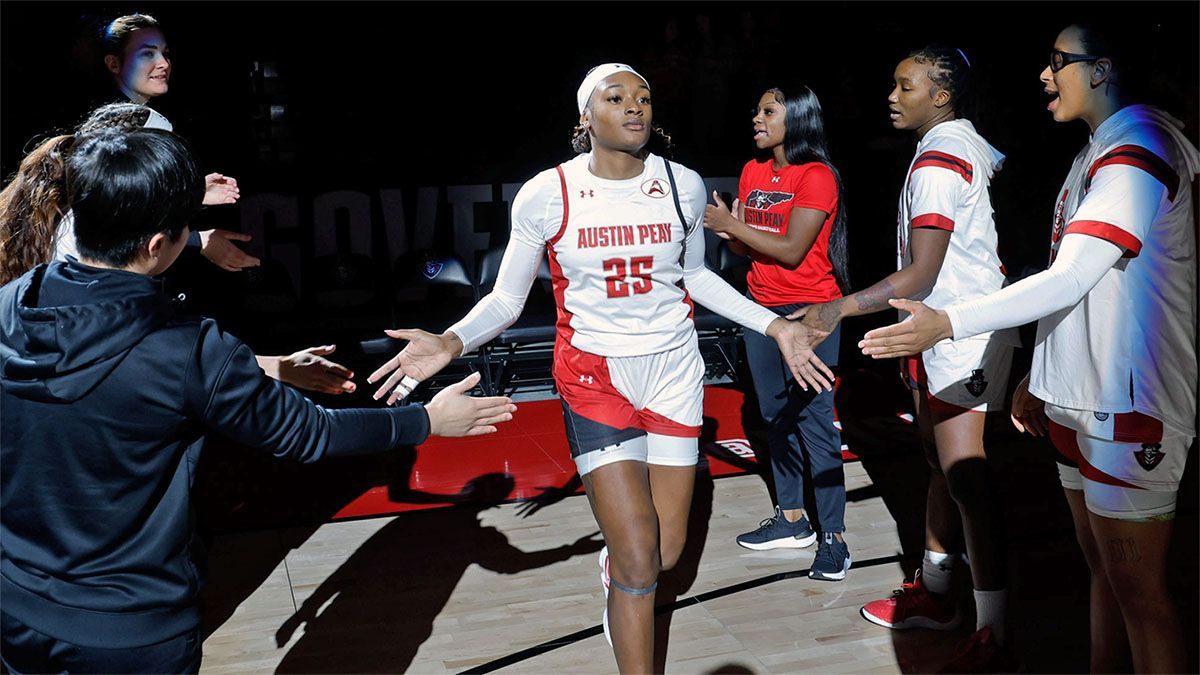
[449, 237, 544, 354]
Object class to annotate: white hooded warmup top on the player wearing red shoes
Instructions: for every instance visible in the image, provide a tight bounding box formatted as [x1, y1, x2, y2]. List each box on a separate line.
[896, 120, 1015, 344]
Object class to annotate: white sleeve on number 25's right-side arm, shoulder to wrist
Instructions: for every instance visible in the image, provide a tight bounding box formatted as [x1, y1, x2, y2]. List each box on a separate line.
[679, 172, 779, 335]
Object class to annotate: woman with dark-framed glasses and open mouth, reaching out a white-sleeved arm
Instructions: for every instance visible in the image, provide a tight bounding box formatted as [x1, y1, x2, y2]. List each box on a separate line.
[862, 24, 1200, 673]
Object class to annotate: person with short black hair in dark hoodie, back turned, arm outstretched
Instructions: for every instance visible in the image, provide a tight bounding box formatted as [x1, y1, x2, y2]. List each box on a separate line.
[0, 130, 515, 673]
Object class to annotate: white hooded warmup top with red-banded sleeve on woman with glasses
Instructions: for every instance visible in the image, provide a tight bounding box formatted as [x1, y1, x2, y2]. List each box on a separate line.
[1030, 106, 1200, 435]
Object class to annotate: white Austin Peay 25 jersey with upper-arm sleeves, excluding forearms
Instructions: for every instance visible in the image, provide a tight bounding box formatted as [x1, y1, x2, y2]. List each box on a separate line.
[512, 154, 706, 357]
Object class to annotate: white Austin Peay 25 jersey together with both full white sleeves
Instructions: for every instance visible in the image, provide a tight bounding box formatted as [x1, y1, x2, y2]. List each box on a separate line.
[450, 154, 778, 357]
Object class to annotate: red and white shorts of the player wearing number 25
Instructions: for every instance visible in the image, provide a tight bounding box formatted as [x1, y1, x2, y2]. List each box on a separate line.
[554, 334, 704, 472]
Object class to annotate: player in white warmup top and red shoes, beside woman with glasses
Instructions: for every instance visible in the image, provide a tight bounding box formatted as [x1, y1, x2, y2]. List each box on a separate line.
[805, 44, 1018, 673]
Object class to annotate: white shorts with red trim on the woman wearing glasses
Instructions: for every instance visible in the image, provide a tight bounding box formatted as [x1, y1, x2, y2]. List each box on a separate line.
[1046, 405, 1192, 520]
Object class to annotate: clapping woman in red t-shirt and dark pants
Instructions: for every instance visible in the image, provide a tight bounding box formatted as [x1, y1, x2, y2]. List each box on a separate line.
[704, 85, 850, 581]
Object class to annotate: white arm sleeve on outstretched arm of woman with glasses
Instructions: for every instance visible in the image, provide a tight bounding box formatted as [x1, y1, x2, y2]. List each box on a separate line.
[946, 232, 1124, 340]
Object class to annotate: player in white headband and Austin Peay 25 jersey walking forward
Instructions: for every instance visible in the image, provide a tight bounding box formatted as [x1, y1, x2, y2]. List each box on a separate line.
[368, 64, 833, 673]
